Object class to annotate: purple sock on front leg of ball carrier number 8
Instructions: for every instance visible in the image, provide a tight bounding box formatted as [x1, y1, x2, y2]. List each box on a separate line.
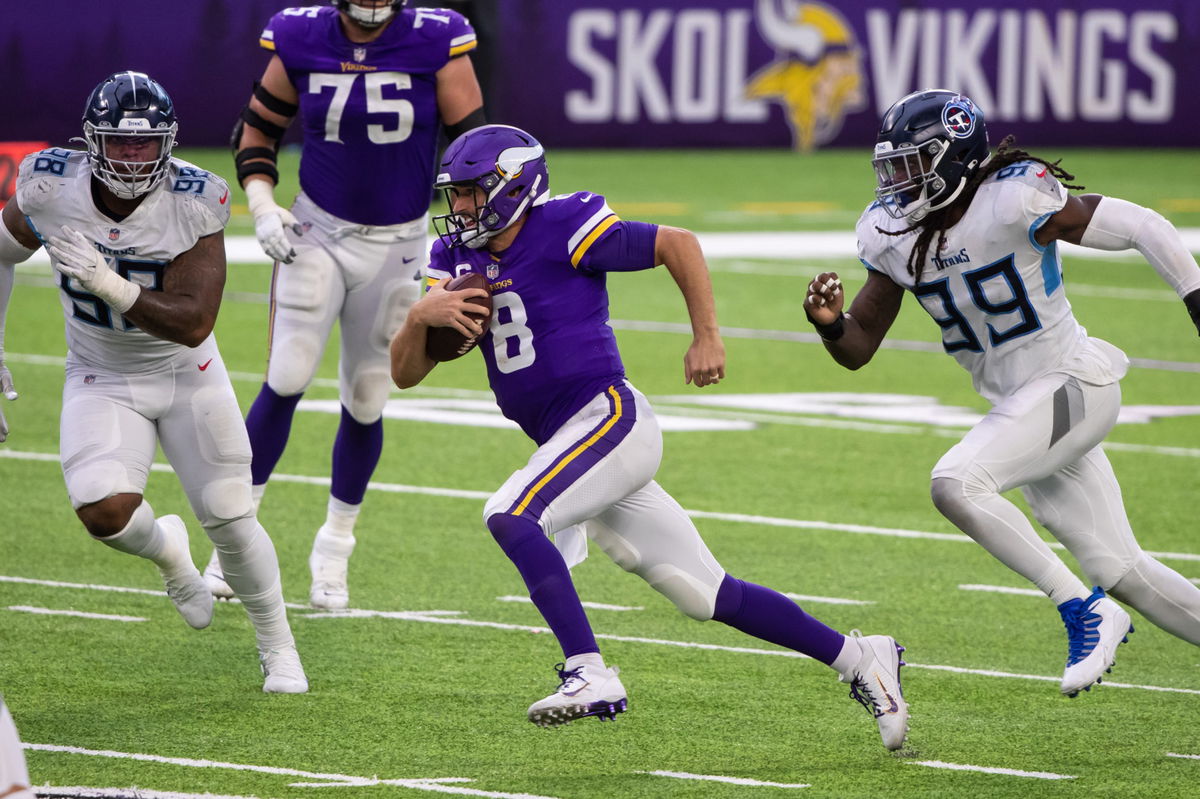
[487, 513, 600, 657]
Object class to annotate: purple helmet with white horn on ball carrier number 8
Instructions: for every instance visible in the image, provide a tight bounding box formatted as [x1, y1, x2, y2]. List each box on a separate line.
[433, 125, 550, 250]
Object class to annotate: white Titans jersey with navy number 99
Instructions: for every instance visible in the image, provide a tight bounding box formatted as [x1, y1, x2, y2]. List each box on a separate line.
[857, 161, 1121, 403]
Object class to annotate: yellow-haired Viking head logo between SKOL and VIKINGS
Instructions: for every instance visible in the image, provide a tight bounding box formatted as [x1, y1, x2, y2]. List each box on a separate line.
[746, 0, 866, 150]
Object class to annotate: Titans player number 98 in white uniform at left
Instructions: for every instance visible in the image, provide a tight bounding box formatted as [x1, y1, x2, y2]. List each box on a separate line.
[0, 72, 308, 693]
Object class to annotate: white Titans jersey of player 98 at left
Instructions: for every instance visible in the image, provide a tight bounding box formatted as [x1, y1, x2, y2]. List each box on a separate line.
[16, 149, 229, 371]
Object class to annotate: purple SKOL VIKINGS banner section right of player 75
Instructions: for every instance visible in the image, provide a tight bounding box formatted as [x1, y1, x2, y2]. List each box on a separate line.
[493, 0, 1200, 150]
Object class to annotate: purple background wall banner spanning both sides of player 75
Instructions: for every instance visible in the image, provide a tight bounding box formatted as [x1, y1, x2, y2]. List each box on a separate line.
[0, 0, 1200, 147]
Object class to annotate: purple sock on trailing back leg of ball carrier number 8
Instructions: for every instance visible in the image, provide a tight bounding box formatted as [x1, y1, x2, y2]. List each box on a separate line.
[713, 575, 845, 666]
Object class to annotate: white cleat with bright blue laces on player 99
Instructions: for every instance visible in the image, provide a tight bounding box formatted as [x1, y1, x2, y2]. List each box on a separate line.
[1058, 588, 1133, 697]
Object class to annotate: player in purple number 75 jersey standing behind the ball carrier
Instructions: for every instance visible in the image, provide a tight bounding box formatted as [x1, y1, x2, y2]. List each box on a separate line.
[205, 0, 484, 608]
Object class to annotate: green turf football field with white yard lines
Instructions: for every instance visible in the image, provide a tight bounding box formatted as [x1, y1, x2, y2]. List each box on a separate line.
[0, 150, 1200, 799]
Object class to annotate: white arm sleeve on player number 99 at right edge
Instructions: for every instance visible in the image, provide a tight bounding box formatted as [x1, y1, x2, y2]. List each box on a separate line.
[1079, 197, 1200, 298]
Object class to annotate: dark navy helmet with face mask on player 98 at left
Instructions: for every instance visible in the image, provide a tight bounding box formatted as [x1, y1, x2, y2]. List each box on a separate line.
[83, 72, 179, 199]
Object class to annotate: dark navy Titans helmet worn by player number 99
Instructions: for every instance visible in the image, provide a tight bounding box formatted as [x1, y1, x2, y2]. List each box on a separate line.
[871, 89, 989, 223]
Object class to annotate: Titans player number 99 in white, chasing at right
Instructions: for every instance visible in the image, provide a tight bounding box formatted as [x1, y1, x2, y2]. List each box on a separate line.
[804, 89, 1200, 696]
